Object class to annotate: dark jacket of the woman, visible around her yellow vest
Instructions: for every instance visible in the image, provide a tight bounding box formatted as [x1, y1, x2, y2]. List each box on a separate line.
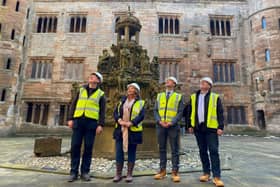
[113, 97, 145, 144]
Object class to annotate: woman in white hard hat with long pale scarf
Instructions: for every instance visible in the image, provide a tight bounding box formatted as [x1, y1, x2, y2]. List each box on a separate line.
[113, 83, 145, 182]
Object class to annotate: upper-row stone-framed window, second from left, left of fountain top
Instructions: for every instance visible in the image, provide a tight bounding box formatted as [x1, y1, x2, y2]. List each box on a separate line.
[67, 12, 88, 34]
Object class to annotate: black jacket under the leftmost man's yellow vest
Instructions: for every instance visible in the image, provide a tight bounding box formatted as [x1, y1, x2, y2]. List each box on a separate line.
[68, 85, 106, 126]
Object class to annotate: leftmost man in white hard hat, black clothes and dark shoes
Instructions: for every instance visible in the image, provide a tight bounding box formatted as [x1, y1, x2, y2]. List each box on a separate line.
[68, 72, 106, 182]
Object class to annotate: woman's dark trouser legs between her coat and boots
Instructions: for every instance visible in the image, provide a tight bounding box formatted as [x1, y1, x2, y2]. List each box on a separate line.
[116, 140, 137, 163]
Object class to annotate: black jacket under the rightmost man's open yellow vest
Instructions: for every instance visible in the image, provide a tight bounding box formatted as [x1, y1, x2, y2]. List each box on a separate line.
[184, 90, 224, 132]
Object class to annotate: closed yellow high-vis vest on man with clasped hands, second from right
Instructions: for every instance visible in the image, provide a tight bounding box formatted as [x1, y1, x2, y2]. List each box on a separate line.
[157, 92, 182, 122]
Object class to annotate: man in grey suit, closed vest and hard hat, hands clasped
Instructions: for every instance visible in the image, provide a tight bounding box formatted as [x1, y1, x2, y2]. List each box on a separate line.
[154, 77, 184, 182]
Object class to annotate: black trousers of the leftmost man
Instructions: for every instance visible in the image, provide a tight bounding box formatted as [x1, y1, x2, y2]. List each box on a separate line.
[70, 118, 97, 175]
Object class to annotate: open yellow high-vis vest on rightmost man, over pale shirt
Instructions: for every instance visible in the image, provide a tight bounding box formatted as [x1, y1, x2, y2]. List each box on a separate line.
[191, 92, 219, 129]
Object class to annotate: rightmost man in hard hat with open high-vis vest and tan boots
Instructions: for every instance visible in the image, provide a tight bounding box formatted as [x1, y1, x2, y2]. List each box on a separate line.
[185, 77, 224, 187]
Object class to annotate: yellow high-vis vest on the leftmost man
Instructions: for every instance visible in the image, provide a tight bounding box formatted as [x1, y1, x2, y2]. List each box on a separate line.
[74, 87, 104, 120]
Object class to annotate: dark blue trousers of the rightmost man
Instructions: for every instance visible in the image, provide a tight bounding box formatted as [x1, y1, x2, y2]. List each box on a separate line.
[195, 131, 221, 177]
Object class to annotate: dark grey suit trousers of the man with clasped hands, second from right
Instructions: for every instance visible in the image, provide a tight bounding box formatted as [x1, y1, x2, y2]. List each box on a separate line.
[157, 125, 180, 171]
